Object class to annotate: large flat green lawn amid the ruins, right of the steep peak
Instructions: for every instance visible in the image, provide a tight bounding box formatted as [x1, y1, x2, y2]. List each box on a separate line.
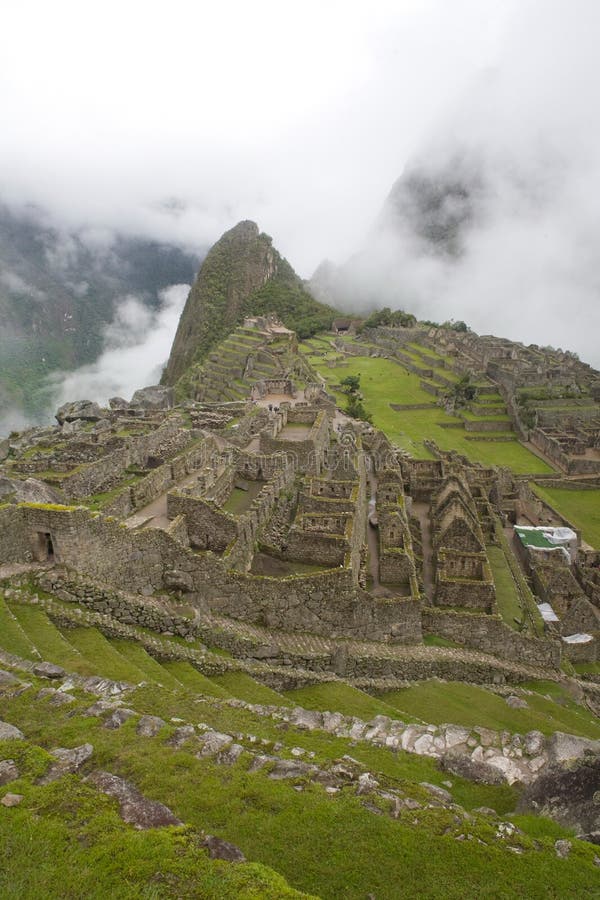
[310, 348, 554, 475]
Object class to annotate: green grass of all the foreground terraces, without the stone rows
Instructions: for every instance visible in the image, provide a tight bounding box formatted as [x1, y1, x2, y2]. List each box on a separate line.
[0, 588, 600, 900]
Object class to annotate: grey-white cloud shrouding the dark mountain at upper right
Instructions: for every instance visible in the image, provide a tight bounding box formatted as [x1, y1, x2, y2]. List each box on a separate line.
[322, 0, 600, 367]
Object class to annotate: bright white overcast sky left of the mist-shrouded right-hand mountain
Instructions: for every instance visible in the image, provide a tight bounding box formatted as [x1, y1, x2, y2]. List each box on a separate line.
[0, 0, 513, 275]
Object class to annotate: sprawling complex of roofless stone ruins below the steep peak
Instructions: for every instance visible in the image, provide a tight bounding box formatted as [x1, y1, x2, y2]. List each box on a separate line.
[0, 319, 600, 680]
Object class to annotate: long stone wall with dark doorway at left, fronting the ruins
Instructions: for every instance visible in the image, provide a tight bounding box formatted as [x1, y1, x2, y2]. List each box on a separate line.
[2, 504, 420, 641]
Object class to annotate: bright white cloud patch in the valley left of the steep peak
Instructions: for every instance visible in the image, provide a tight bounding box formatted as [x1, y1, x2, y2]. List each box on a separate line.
[49, 284, 190, 406]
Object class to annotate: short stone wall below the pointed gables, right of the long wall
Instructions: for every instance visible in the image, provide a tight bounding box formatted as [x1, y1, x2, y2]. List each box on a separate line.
[423, 607, 561, 668]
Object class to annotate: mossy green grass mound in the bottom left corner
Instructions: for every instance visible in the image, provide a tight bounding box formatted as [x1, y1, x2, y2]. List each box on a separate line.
[0, 776, 305, 900]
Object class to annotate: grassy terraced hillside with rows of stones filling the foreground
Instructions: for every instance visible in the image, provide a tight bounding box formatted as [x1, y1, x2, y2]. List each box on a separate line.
[0, 581, 600, 898]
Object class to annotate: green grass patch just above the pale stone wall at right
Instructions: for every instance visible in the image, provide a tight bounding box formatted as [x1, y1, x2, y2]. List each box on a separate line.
[380, 680, 600, 739]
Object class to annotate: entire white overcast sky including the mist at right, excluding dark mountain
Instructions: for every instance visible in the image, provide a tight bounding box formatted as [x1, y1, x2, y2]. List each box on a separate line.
[0, 0, 600, 362]
